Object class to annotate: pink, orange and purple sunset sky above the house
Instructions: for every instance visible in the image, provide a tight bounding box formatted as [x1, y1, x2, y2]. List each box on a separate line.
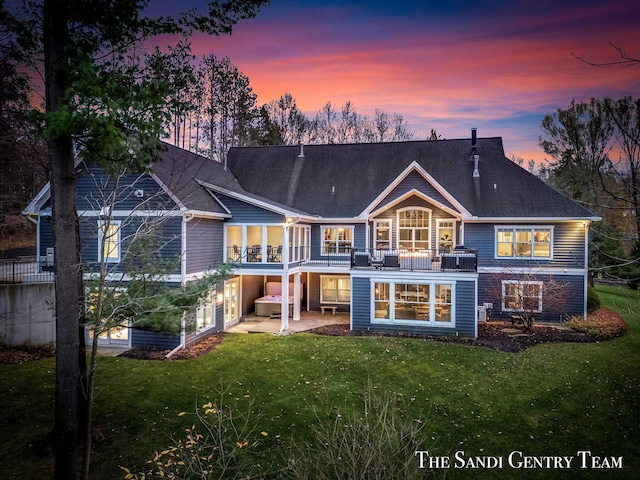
[162, 0, 640, 162]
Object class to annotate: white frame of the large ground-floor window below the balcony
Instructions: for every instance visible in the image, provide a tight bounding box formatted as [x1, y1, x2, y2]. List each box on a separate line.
[370, 278, 456, 328]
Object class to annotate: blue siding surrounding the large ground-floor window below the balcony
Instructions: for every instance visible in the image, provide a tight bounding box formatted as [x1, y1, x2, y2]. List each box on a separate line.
[351, 277, 477, 337]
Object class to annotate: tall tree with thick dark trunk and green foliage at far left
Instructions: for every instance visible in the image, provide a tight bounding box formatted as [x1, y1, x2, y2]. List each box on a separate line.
[8, 0, 266, 479]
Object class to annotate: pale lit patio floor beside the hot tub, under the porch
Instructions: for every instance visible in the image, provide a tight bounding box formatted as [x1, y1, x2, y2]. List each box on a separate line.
[225, 311, 349, 333]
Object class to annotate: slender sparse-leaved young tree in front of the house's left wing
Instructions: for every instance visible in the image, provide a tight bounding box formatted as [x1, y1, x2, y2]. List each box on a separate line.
[82, 165, 232, 478]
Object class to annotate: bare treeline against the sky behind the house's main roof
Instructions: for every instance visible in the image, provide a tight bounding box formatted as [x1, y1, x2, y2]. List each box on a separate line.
[155, 48, 416, 161]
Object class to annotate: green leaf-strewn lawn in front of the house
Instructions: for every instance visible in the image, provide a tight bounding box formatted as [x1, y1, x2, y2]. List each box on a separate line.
[0, 287, 640, 479]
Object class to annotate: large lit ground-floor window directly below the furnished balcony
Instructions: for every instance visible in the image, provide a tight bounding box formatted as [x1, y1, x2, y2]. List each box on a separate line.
[372, 282, 455, 327]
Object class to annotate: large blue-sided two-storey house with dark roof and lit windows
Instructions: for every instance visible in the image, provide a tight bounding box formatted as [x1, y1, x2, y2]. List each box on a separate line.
[25, 129, 599, 346]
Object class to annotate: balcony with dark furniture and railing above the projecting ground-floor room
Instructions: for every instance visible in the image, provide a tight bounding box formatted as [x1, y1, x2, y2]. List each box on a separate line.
[351, 247, 478, 272]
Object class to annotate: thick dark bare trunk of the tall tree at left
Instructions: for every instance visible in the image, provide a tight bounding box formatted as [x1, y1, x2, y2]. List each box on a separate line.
[44, 0, 81, 480]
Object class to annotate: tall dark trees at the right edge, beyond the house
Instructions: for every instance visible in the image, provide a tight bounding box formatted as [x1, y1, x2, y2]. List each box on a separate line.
[540, 97, 640, 279]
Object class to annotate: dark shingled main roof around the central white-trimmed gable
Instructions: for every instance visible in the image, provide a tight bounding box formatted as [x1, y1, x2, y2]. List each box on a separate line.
[228, 137, 597, 219]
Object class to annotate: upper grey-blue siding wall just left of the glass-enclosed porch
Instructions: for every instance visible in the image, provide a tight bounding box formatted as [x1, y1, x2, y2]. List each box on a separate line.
[186, 218, 223, 273]
